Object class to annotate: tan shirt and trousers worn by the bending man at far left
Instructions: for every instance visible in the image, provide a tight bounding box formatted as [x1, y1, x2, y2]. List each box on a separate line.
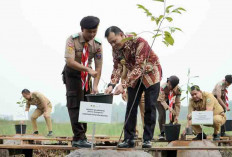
[26, 92, 52, 131]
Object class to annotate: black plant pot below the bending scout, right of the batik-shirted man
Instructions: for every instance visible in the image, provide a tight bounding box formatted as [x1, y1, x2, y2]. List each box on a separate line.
[164, 124, 181, 142]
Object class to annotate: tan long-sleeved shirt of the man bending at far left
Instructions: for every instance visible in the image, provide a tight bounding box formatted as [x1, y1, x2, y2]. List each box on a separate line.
[26, 92, 52, 111]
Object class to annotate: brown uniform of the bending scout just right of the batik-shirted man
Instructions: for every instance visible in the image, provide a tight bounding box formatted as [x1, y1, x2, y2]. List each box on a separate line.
[157, 83, 181, 134]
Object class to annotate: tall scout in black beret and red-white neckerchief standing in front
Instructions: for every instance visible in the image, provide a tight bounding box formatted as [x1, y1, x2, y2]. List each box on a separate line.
[63, 16, 103, 148]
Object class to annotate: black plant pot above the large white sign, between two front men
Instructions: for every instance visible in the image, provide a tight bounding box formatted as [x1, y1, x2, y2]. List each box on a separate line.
[85, 93, 113, 104]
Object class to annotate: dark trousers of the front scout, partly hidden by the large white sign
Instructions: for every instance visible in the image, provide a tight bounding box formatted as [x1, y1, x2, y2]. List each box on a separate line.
[62, 66, 90, 141]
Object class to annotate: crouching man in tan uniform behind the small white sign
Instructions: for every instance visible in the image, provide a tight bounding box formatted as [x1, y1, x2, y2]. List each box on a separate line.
[187, 85, 226, 140]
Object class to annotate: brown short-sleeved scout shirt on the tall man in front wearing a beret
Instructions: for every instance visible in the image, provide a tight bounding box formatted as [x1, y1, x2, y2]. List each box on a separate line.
[65, 33, 103, 68]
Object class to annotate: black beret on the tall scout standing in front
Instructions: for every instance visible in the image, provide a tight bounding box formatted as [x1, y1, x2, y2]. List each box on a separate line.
[80, 16, 100, 29]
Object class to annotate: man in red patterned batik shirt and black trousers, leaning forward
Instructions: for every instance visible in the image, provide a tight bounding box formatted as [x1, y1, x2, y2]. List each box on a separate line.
[105, 26, 162, 148]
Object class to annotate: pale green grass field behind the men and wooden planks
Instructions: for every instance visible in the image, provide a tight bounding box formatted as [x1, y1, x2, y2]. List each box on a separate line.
[0, 120, 230, 136]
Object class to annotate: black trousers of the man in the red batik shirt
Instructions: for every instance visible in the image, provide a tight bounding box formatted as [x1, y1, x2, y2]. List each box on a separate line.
[124, 81, 160, 141]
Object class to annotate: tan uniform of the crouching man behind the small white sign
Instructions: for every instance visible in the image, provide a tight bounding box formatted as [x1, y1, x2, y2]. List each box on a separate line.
[188, 92, 226, 135]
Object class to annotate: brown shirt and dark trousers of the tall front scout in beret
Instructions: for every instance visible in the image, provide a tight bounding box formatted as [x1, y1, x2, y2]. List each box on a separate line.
[62, 33, 103, 141]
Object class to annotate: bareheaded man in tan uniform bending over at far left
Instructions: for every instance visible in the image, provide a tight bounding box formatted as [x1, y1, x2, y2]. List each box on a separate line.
[22, 89, 52, 136]
